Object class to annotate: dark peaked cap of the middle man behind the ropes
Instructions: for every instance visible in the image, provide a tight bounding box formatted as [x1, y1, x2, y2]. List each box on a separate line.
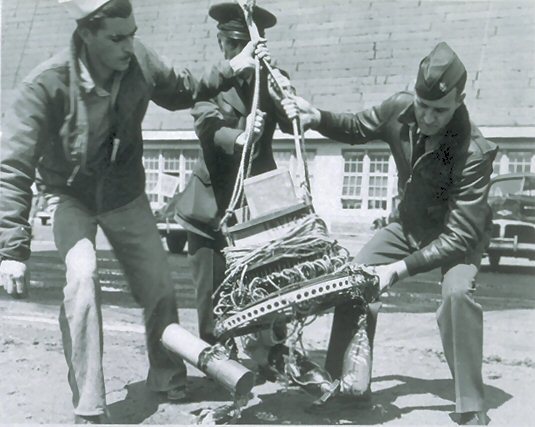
[208, 2, 277, 40]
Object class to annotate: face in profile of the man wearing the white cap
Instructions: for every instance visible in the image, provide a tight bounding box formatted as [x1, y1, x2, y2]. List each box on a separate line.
[81, 13, 137, 72]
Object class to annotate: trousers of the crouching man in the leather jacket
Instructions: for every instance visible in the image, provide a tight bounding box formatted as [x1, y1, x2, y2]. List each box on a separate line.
[326, 223, 484, 412]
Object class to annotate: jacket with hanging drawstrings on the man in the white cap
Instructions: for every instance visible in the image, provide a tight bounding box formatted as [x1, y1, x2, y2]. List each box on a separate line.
[0, 33, 239, 261]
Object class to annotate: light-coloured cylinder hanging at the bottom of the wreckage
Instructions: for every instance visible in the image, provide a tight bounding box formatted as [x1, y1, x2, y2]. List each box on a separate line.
[161, 323, 254, 397]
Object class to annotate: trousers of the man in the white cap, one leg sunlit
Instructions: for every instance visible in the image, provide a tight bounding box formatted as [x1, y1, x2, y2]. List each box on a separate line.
[53, 194, 186, 416]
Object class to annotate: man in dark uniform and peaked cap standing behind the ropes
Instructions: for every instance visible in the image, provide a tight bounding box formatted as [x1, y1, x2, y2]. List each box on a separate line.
[178, 2, 298, 379]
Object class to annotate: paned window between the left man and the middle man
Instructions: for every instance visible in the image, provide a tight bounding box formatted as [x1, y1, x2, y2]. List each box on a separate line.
[143, 148, 199, 204]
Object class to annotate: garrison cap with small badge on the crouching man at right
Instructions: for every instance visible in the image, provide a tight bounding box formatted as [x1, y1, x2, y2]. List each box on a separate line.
[414, 42, 466, 101]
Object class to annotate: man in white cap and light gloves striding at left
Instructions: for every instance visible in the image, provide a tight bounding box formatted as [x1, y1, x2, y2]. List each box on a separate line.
[0, 0, 267, 422]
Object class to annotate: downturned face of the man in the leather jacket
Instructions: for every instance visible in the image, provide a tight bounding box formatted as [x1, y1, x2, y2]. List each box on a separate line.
[414, 88, 464, 136]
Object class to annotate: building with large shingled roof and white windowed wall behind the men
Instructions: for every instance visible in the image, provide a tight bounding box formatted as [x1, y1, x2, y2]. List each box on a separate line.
[2, 0, 535, 229]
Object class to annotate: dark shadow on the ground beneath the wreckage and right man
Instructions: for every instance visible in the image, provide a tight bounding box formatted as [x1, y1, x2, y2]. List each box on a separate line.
[239, 375, 512, 425]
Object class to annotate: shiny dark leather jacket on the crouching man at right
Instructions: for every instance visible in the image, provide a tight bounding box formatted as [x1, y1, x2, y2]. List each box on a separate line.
[317, 92, 498, 275]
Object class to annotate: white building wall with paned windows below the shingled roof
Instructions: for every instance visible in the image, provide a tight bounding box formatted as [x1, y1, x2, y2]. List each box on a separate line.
[144, 138, 535, 230]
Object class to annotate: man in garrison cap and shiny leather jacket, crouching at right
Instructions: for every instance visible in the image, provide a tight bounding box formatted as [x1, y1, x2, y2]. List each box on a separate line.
[283, 42, 497, 424]
